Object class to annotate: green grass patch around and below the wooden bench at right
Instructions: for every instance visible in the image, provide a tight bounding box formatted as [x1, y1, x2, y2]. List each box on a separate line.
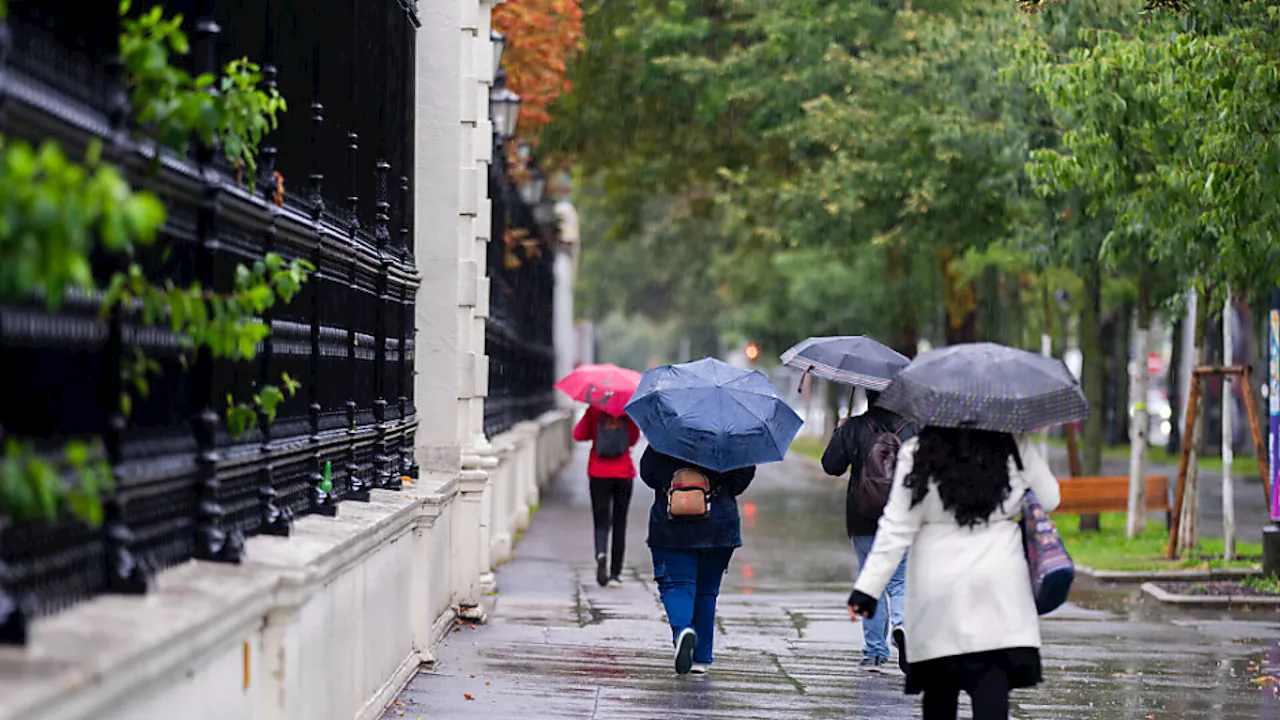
[1053, 512, 1262, 570]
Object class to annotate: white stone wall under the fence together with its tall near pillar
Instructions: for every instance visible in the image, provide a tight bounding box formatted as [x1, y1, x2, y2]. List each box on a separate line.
[0, 0, 572, 720]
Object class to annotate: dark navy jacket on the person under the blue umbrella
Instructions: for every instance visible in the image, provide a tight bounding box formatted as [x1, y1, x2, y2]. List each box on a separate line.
[640, 447, 755, 550]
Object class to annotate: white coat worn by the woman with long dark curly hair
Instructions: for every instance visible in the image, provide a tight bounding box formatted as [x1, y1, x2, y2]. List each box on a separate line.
[854, 430, 1060, 662]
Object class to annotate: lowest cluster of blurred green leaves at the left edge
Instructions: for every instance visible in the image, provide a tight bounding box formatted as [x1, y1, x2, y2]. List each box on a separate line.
[0, 438, 115, 528]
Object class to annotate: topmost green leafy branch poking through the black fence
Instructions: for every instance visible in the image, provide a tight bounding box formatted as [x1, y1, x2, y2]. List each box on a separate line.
[120, 0, 288, 188]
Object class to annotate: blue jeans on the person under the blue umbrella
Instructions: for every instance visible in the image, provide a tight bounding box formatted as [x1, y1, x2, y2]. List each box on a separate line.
[649, 547, 735, 662]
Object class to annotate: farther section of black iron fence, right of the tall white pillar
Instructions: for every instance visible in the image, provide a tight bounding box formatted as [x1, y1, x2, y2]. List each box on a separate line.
[484, 151, 557, 437]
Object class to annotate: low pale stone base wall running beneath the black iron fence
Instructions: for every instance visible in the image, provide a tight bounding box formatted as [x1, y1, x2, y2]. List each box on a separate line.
[0, 410, 572, 720]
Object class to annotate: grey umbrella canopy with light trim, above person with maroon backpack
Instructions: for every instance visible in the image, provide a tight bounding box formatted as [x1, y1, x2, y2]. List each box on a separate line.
[782, 336, 911, 391]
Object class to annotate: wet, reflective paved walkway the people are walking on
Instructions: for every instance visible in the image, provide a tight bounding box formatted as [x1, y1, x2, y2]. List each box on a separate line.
[387, 445, 1280, 720]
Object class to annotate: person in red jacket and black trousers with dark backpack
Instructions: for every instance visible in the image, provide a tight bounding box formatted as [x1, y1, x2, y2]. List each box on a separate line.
[573, 406, 640, 587]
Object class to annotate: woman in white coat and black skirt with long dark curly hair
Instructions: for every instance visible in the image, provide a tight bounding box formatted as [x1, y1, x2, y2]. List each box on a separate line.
[849, 427, 1059, 720]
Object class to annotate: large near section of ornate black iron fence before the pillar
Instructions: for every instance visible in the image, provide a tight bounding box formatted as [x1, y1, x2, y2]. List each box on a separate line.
[0, 0, 419, 643]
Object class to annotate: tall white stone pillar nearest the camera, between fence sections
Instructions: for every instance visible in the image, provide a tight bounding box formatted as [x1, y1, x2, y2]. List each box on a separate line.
[413, 0, 497, 611]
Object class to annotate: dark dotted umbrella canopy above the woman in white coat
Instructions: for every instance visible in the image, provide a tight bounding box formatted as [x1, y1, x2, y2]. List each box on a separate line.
[878, 342, 1089, 434]
